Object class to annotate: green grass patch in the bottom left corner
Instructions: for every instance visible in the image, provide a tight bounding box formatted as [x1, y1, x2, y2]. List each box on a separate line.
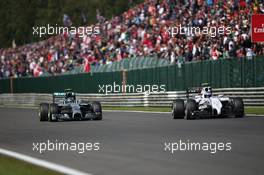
[0, 155, 61, 175]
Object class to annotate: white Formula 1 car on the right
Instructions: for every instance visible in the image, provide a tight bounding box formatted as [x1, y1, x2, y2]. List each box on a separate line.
[172, 86, 244, 120]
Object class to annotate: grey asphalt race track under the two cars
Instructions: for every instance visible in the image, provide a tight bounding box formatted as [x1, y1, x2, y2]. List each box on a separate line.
[0, 108, 264, 175]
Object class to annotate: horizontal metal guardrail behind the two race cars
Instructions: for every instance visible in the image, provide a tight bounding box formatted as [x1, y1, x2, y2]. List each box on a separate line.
[0, 87, 264, 107]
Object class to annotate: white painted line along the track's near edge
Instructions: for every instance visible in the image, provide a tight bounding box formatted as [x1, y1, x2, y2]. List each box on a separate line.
[0, 148, 92, 175]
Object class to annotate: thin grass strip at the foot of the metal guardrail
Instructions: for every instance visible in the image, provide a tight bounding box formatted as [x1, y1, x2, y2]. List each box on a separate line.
[103, 106, 264, 114]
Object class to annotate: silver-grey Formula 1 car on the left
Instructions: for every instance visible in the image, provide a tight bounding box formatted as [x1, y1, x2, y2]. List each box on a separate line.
[39, 89, 103, 122]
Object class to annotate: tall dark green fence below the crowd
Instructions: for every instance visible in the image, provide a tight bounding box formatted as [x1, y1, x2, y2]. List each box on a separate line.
[0, 57, 264, 93]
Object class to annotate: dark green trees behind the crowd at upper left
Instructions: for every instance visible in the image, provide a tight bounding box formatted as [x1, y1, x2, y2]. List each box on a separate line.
[0, 0, 142, 48]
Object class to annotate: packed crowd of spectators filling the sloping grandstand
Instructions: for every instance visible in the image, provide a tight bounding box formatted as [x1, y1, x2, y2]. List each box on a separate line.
[0, 0, 264, 78]
